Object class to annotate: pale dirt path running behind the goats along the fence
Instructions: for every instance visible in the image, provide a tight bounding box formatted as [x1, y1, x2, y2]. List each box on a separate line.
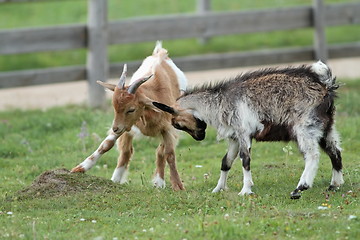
[0, 57, 360, 111]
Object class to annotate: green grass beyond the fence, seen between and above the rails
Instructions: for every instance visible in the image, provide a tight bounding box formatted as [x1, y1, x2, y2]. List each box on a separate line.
[0, 0, 360, 71]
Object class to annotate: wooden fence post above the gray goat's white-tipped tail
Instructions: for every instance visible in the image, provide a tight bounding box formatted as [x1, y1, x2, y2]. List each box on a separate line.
[313, 0, 328, 62]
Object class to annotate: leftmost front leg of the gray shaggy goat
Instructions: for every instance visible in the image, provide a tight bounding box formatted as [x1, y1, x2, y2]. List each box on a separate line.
[212, 139, 239, 193]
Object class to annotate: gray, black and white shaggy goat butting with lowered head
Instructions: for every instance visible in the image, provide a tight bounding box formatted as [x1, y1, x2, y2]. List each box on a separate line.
[153, 61, 344, 199]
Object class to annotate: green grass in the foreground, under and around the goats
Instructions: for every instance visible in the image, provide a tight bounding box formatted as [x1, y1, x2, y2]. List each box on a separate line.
[0, 79, 360, 239]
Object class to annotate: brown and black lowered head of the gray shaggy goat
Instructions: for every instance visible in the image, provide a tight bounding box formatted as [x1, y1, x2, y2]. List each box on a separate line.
[153, 102, 207, 141]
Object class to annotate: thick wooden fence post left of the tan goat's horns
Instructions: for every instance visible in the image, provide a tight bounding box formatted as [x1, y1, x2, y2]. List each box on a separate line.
[86, 0, 109, 108]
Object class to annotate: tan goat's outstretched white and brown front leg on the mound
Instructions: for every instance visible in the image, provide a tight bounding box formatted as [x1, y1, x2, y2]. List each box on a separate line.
[71, 132, 119, 172]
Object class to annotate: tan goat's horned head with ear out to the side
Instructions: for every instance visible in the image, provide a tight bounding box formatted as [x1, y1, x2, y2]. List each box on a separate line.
[97, 64, 152, 135]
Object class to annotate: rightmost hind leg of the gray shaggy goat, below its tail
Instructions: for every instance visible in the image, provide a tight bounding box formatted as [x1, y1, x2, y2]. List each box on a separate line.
[320, 126, 344, 191]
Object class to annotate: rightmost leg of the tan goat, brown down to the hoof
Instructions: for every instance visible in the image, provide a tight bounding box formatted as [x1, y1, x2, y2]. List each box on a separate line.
[157, 131, 185, 191]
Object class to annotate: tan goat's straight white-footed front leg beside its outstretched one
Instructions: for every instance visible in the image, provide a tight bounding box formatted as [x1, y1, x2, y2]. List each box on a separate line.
[111, 132, 134, 184]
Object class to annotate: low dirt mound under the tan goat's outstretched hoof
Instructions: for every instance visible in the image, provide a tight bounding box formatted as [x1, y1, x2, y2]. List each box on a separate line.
[12, 168, 119, 200]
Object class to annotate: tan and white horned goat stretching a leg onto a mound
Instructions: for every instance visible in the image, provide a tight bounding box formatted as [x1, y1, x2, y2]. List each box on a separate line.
[72, 42, 187, 190]
